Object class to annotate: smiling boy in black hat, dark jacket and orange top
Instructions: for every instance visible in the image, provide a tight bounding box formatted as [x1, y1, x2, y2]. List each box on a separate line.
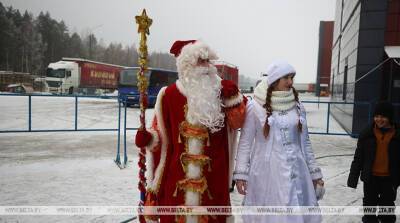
[347, 102, 400, 223]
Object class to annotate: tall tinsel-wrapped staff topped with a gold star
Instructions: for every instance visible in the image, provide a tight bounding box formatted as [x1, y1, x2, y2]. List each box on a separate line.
[135, 9, 153, 223]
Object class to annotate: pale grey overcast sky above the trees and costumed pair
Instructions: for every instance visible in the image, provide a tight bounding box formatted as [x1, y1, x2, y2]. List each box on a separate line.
[1, 0, 336, 83]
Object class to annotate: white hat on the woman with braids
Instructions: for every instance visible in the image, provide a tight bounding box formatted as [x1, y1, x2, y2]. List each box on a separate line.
[266, 60, 296, 86]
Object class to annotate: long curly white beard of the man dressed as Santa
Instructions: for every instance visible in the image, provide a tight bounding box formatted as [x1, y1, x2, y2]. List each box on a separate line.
[179, 66, 225, 133]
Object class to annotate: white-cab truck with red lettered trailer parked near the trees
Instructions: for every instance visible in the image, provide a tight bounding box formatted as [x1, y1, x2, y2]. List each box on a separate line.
[46, 58, 125, 94]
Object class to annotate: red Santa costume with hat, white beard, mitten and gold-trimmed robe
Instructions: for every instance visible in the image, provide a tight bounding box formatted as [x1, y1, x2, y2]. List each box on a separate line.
[136, 41, 246, 223]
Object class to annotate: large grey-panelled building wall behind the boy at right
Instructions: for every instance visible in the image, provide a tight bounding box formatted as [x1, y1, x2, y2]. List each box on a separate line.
[330, 0, 400, 134]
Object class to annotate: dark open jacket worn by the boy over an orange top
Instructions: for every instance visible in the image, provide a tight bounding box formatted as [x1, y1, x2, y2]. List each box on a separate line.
[347, 125, 400, 188]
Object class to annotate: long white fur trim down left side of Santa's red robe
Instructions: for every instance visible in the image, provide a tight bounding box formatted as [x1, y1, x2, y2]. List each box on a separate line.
[148, 87, 169, 192]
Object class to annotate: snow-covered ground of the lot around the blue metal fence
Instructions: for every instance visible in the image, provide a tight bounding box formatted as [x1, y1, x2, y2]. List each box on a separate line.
[0, 95, 400, 223]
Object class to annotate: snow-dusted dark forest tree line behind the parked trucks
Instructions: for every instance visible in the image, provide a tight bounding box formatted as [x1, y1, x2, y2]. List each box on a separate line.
[0, 2, 176, 76]
